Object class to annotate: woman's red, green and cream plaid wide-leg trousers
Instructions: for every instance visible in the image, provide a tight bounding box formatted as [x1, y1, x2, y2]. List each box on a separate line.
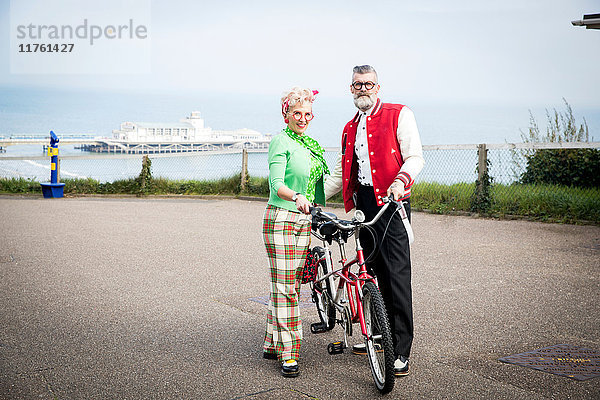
[263, 205, 310, 361]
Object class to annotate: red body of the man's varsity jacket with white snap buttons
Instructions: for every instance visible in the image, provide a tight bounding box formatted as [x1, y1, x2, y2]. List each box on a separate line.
[342, 99, 412, 212]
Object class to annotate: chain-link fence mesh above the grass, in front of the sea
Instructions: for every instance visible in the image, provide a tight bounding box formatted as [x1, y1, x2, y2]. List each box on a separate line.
[0, 142, 600, 185]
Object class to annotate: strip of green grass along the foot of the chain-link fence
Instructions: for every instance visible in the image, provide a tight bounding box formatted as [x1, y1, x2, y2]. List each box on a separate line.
[0, 174, 600, 224]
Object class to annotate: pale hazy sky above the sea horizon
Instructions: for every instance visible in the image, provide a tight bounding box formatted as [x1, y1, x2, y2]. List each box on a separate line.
[0, 0, 600, 108]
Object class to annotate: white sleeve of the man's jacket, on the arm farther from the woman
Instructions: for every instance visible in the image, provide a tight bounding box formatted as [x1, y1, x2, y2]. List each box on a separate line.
[396, 106, 425, 185]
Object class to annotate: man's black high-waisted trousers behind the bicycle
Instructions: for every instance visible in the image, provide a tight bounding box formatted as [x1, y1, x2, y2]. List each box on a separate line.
[356, 185, 413, 357]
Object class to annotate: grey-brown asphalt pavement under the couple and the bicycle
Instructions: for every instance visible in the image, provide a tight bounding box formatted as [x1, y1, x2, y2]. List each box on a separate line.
[0, 196, 600, 399]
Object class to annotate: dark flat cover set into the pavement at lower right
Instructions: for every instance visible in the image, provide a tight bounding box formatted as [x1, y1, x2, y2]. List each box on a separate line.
[500, 344, 600, 381]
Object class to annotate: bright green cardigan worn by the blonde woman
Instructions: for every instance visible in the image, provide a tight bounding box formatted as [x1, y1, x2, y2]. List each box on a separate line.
[269, 133, 325, 211]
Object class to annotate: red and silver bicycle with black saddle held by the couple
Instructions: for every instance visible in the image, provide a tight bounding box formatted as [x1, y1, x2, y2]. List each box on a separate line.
[309, 198, 412, 393]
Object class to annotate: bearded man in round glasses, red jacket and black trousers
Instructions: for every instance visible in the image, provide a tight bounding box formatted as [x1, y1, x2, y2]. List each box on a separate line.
[325, 65, 425, 376]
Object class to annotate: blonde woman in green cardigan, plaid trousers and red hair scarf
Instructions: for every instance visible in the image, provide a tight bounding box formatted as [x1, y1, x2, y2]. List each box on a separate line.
[263, 87, 329, 377]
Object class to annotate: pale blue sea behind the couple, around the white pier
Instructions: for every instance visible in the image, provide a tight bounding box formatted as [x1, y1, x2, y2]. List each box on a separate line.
[0, 86, 600, 183]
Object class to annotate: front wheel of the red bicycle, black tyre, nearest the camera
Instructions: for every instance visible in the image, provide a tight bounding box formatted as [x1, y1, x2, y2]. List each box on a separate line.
[362, 282, 396, 393]
